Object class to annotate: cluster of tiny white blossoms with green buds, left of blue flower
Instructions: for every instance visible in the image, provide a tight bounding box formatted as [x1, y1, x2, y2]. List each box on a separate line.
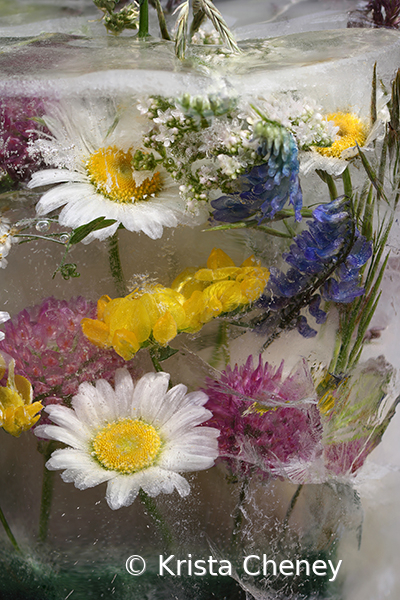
[142, 96, 260, 205]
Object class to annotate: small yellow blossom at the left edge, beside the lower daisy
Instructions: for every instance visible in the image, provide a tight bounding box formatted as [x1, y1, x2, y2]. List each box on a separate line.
[0, 356, 43, 437]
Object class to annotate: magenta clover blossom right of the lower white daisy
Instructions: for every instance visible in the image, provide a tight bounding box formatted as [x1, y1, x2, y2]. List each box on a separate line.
[205, 356, 322, 476]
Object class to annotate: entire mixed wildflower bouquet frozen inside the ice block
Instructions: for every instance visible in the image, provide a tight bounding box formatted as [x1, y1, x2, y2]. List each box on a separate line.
[0, 39, 400, 597]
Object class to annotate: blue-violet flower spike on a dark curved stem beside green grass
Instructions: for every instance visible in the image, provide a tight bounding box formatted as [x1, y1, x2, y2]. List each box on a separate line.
[260, 197, 372, 337]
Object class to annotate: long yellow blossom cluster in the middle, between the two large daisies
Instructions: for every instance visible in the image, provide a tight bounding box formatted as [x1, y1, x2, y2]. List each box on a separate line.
[82, 248, 269, 360]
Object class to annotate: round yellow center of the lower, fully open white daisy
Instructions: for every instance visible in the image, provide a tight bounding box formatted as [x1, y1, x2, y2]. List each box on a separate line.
[92, 419, 162, 474]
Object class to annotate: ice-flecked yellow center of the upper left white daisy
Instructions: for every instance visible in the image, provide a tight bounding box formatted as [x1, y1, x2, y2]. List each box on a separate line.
[86, 146, 163, 203]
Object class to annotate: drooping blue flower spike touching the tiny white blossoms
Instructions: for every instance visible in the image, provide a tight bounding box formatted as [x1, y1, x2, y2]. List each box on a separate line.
[211, 121, 303, 223]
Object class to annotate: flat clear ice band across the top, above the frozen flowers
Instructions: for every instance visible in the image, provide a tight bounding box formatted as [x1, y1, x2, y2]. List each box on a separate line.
[0, 29, 400, 117]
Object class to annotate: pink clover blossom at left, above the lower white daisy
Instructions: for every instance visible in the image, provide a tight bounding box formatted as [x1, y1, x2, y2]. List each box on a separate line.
[0, 297, 138, 423]
